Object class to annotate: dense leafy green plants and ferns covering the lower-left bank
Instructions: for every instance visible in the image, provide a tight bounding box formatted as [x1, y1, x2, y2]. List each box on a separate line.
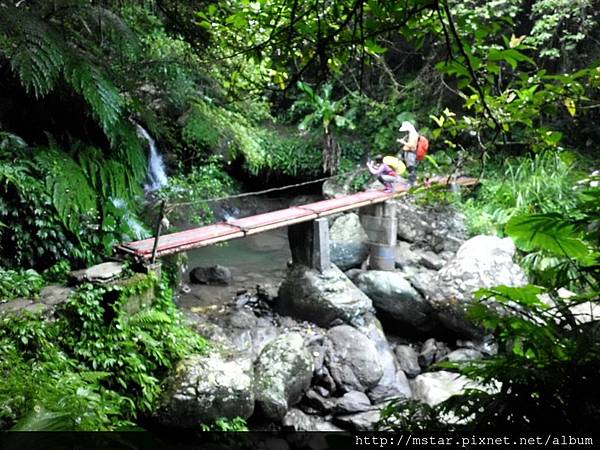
[0, 275, 206, 430]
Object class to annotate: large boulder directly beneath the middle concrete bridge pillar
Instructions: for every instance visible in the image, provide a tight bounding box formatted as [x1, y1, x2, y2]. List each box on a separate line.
[275, 265, 373, 327]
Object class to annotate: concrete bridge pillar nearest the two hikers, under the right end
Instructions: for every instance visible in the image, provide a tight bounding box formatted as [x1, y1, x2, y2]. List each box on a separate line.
[360, 201, 398, 270]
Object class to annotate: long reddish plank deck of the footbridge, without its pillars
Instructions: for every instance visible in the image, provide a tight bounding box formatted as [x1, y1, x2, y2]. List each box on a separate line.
[117, 177, 478, 259]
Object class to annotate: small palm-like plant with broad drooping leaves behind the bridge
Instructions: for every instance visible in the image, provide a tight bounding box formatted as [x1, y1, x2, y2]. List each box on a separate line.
[294, 81, 354, 173]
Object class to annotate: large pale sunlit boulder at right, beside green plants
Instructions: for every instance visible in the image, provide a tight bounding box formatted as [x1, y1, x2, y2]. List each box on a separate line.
[429, 236, 527, 338]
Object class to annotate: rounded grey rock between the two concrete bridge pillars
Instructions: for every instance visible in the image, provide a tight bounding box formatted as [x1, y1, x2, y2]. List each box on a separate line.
[329, 213, 369, 270]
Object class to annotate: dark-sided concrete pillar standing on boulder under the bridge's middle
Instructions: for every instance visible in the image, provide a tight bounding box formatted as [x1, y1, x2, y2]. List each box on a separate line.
[288, 218, 331, 273]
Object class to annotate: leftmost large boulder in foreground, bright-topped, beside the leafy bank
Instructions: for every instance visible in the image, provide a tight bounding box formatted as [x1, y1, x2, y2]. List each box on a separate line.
[156, 351, 254, 429]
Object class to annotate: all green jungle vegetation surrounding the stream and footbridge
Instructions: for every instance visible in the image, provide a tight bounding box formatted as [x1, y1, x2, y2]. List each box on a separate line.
[0, 0, 600, 430]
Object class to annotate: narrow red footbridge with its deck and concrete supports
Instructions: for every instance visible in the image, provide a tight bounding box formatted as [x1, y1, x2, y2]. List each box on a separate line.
[117, 177, 478, 268]
